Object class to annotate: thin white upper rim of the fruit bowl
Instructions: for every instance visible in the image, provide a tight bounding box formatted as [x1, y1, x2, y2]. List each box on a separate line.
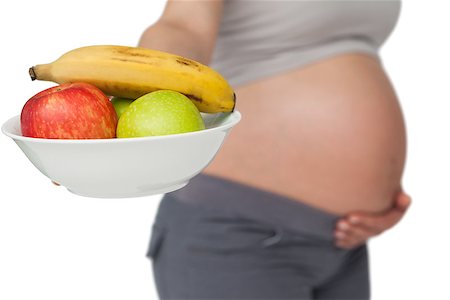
[2, 110, 241, 144]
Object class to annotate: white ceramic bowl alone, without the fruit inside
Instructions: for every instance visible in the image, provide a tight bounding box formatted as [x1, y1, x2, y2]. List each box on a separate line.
[2, 111, 241, 198]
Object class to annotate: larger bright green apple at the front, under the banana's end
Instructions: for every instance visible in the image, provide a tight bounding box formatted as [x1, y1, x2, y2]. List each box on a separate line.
[117, 90, 205, 138]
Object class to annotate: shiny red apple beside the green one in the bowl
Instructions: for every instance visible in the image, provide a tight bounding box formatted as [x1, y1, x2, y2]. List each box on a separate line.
[20, 83, 118, 139]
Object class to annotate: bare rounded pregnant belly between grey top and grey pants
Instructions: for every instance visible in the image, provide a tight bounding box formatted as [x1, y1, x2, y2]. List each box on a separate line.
[205, 54, 406, 214]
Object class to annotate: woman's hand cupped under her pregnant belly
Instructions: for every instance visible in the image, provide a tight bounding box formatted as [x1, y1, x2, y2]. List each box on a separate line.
[335, 191, 411, 249]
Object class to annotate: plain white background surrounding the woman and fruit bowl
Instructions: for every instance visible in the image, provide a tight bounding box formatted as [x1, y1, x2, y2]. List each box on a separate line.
[0, 0, 450, 300]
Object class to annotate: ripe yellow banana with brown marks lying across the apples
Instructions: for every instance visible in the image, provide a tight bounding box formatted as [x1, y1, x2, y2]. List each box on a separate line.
[29, 45, 236, 113]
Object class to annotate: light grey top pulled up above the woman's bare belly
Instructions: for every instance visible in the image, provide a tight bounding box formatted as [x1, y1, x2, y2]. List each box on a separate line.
[211, 0, 401, 87]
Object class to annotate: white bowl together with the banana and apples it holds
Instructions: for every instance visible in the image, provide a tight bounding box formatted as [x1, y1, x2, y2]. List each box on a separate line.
[2, 46, 241, 198]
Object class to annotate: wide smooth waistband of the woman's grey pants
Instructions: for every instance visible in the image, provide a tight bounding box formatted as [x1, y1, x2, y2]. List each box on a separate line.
[168, 174, 338, 240]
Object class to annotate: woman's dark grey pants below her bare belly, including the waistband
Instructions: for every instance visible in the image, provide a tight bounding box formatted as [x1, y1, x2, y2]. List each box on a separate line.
[148, 175, 369, 299]
